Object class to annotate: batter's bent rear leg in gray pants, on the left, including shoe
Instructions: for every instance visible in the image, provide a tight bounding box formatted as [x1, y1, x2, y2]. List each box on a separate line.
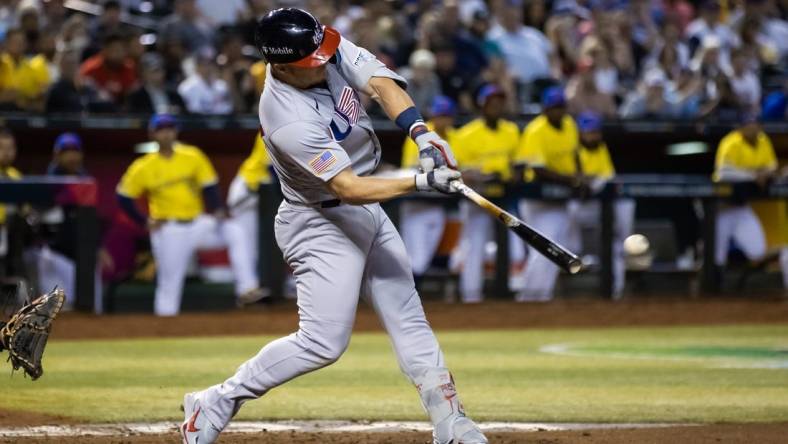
[194, 205, 374, 436]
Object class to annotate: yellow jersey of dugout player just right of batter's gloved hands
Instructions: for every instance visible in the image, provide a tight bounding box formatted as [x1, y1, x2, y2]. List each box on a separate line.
[453, 119, 520, 180]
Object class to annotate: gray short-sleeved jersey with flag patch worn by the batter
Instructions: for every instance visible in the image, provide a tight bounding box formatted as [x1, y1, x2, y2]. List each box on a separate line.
[260, 38, 406, 204]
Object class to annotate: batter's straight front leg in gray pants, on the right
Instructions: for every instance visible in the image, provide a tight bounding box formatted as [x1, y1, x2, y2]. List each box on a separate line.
[363, 207, 487, 444]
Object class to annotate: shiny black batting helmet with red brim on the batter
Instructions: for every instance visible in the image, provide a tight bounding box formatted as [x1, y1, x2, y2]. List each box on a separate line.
[254, 8, 340, 68]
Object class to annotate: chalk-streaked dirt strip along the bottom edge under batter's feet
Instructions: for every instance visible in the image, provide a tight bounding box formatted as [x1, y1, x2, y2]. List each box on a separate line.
[0, 421, 788, 444]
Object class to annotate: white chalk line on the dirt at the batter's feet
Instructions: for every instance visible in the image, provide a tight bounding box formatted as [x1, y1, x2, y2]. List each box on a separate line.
[0, 421, 693, 438]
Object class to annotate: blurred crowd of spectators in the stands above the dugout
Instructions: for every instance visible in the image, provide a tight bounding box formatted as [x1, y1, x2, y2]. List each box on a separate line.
[0, 0, 788, 120]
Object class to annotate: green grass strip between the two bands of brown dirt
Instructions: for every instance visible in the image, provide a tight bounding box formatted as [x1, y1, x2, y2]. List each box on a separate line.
[0, 325, 788, 422]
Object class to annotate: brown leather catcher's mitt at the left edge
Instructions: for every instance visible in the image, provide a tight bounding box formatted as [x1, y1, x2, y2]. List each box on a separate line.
[0, 288, 66, 381]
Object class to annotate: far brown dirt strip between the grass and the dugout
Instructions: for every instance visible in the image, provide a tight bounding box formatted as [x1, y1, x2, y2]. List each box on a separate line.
[53, 298, 788, 339]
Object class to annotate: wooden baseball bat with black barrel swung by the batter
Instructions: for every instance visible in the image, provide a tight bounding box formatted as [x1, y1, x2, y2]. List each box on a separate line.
[451, 181, 583, 274]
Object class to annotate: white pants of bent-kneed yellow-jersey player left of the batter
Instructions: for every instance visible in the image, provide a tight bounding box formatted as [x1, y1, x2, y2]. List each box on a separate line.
[150, 215, 257, 316]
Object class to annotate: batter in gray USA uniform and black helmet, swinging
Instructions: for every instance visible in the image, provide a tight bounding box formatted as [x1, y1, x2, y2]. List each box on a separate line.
[181, 8, 487, 444]
